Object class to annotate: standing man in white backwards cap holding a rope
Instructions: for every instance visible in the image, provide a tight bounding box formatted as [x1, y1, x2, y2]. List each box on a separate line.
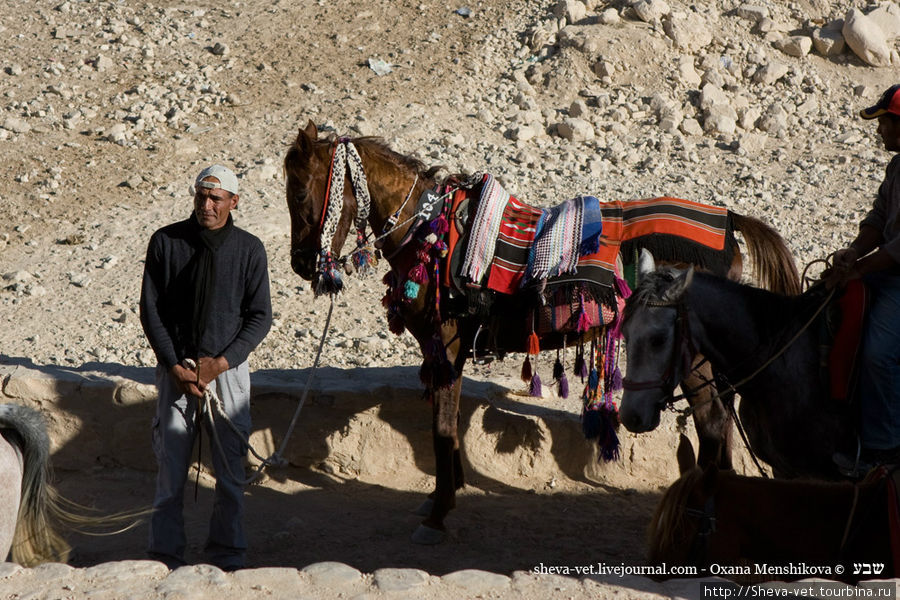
[141, 165, 272, 571]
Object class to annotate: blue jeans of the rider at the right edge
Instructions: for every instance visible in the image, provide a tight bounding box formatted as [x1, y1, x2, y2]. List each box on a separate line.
[859, 273, 900, 450]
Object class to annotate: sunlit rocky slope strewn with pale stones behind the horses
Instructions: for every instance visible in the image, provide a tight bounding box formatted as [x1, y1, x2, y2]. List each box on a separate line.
[0, 0, 900, 596]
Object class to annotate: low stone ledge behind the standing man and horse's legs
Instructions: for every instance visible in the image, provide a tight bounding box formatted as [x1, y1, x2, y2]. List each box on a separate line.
[0, 364, 752, 489]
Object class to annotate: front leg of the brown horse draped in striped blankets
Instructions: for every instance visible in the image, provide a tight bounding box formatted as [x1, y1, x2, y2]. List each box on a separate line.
[412, 323, 465, 544]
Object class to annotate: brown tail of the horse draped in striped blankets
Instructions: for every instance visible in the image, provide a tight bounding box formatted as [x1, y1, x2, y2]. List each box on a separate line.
[731, 212, 800, 296]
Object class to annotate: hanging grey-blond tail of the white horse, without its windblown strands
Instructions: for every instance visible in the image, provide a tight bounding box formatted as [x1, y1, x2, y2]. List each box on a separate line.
[0, 404, 71, 567]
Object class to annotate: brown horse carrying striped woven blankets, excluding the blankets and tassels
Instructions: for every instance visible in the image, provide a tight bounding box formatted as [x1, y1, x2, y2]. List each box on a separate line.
[284, 121, 799, 543]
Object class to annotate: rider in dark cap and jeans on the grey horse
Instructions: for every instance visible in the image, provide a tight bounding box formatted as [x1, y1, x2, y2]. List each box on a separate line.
[828, 84, 900, 471]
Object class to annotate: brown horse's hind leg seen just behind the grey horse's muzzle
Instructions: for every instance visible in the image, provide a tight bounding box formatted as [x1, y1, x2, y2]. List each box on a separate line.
[681, 357, 734, 469]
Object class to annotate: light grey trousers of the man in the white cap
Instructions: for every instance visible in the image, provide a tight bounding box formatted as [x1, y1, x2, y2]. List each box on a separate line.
[147, 361, 250, 568]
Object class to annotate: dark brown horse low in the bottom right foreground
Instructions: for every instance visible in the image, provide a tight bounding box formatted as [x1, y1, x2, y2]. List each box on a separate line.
[648, 436, 896, 581]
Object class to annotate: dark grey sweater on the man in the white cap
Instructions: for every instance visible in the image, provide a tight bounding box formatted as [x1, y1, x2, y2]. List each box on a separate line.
[141, 219, 272, 369]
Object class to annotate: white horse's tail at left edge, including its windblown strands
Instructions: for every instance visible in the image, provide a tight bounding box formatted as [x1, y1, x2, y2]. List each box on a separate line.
[0, 404, 149, 567]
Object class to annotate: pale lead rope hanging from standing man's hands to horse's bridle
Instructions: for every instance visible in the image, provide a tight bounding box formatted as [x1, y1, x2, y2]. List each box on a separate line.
[182, 296, 334, 485]
